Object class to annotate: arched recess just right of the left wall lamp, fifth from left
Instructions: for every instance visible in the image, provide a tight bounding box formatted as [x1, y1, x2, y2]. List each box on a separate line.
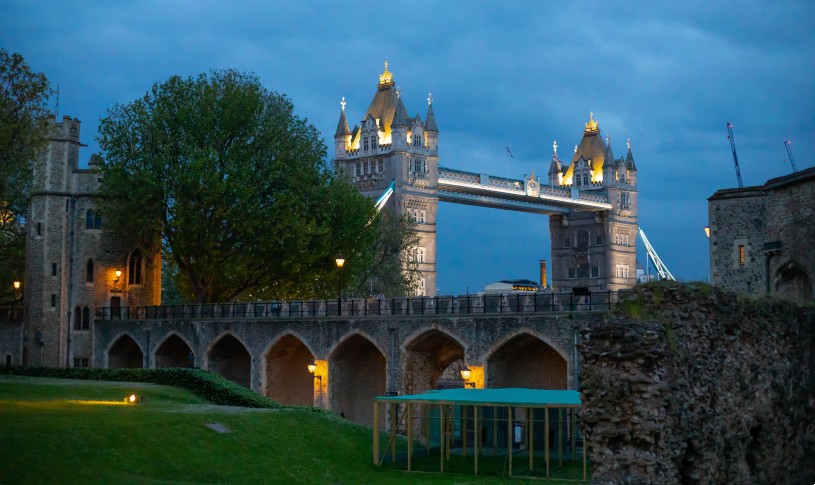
[328, 334, 385, 425]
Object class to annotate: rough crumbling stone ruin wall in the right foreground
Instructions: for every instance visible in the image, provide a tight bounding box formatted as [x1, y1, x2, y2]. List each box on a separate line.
[579, 283, 815, 484]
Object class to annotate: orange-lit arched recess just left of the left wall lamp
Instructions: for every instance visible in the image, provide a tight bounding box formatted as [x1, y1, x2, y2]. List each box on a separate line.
[264, 334, 314, 406]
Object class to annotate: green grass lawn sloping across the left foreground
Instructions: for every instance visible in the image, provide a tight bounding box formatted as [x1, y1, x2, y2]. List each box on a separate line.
[0, 376, 588, 485]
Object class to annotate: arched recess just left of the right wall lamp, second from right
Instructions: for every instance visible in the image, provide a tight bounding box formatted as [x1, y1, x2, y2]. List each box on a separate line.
[402, 329, 464, 394]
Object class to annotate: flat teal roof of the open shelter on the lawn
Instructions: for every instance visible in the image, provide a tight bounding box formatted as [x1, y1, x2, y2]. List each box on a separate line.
[376, 388, 580, 407]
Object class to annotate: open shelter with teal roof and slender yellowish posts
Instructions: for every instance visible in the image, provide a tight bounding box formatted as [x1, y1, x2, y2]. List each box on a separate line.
[373, 388, 586, 480]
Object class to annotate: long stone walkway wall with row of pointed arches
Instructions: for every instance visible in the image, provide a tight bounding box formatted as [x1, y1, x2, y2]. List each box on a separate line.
[93, 293, 613, 424]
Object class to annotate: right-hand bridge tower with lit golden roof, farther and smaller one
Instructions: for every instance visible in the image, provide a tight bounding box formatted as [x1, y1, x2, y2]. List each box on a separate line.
[549, 114, 638, 293]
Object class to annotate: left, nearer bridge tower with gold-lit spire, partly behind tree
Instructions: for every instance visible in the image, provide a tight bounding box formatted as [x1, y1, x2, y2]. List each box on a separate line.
[334, 62, 439, 296]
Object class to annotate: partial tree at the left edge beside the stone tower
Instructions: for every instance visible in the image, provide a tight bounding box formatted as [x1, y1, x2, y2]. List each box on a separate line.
[0, 49, 51, 302]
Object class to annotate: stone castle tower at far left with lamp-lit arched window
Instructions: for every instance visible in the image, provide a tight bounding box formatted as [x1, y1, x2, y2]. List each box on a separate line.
[23, 116, 161, 367]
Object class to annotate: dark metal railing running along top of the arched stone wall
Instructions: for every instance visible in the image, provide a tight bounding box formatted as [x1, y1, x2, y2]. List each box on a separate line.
[96, 291, 617, 320]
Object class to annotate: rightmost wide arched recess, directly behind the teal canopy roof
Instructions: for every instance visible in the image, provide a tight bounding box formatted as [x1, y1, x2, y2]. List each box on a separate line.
[487, 333, 569, 389]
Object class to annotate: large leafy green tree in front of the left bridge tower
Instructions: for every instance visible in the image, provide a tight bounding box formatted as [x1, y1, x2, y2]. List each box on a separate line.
[99, 70, 418, 303]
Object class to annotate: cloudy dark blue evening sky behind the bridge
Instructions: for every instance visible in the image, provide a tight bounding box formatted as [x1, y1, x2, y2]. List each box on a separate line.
[0, 0, 815, 294]
